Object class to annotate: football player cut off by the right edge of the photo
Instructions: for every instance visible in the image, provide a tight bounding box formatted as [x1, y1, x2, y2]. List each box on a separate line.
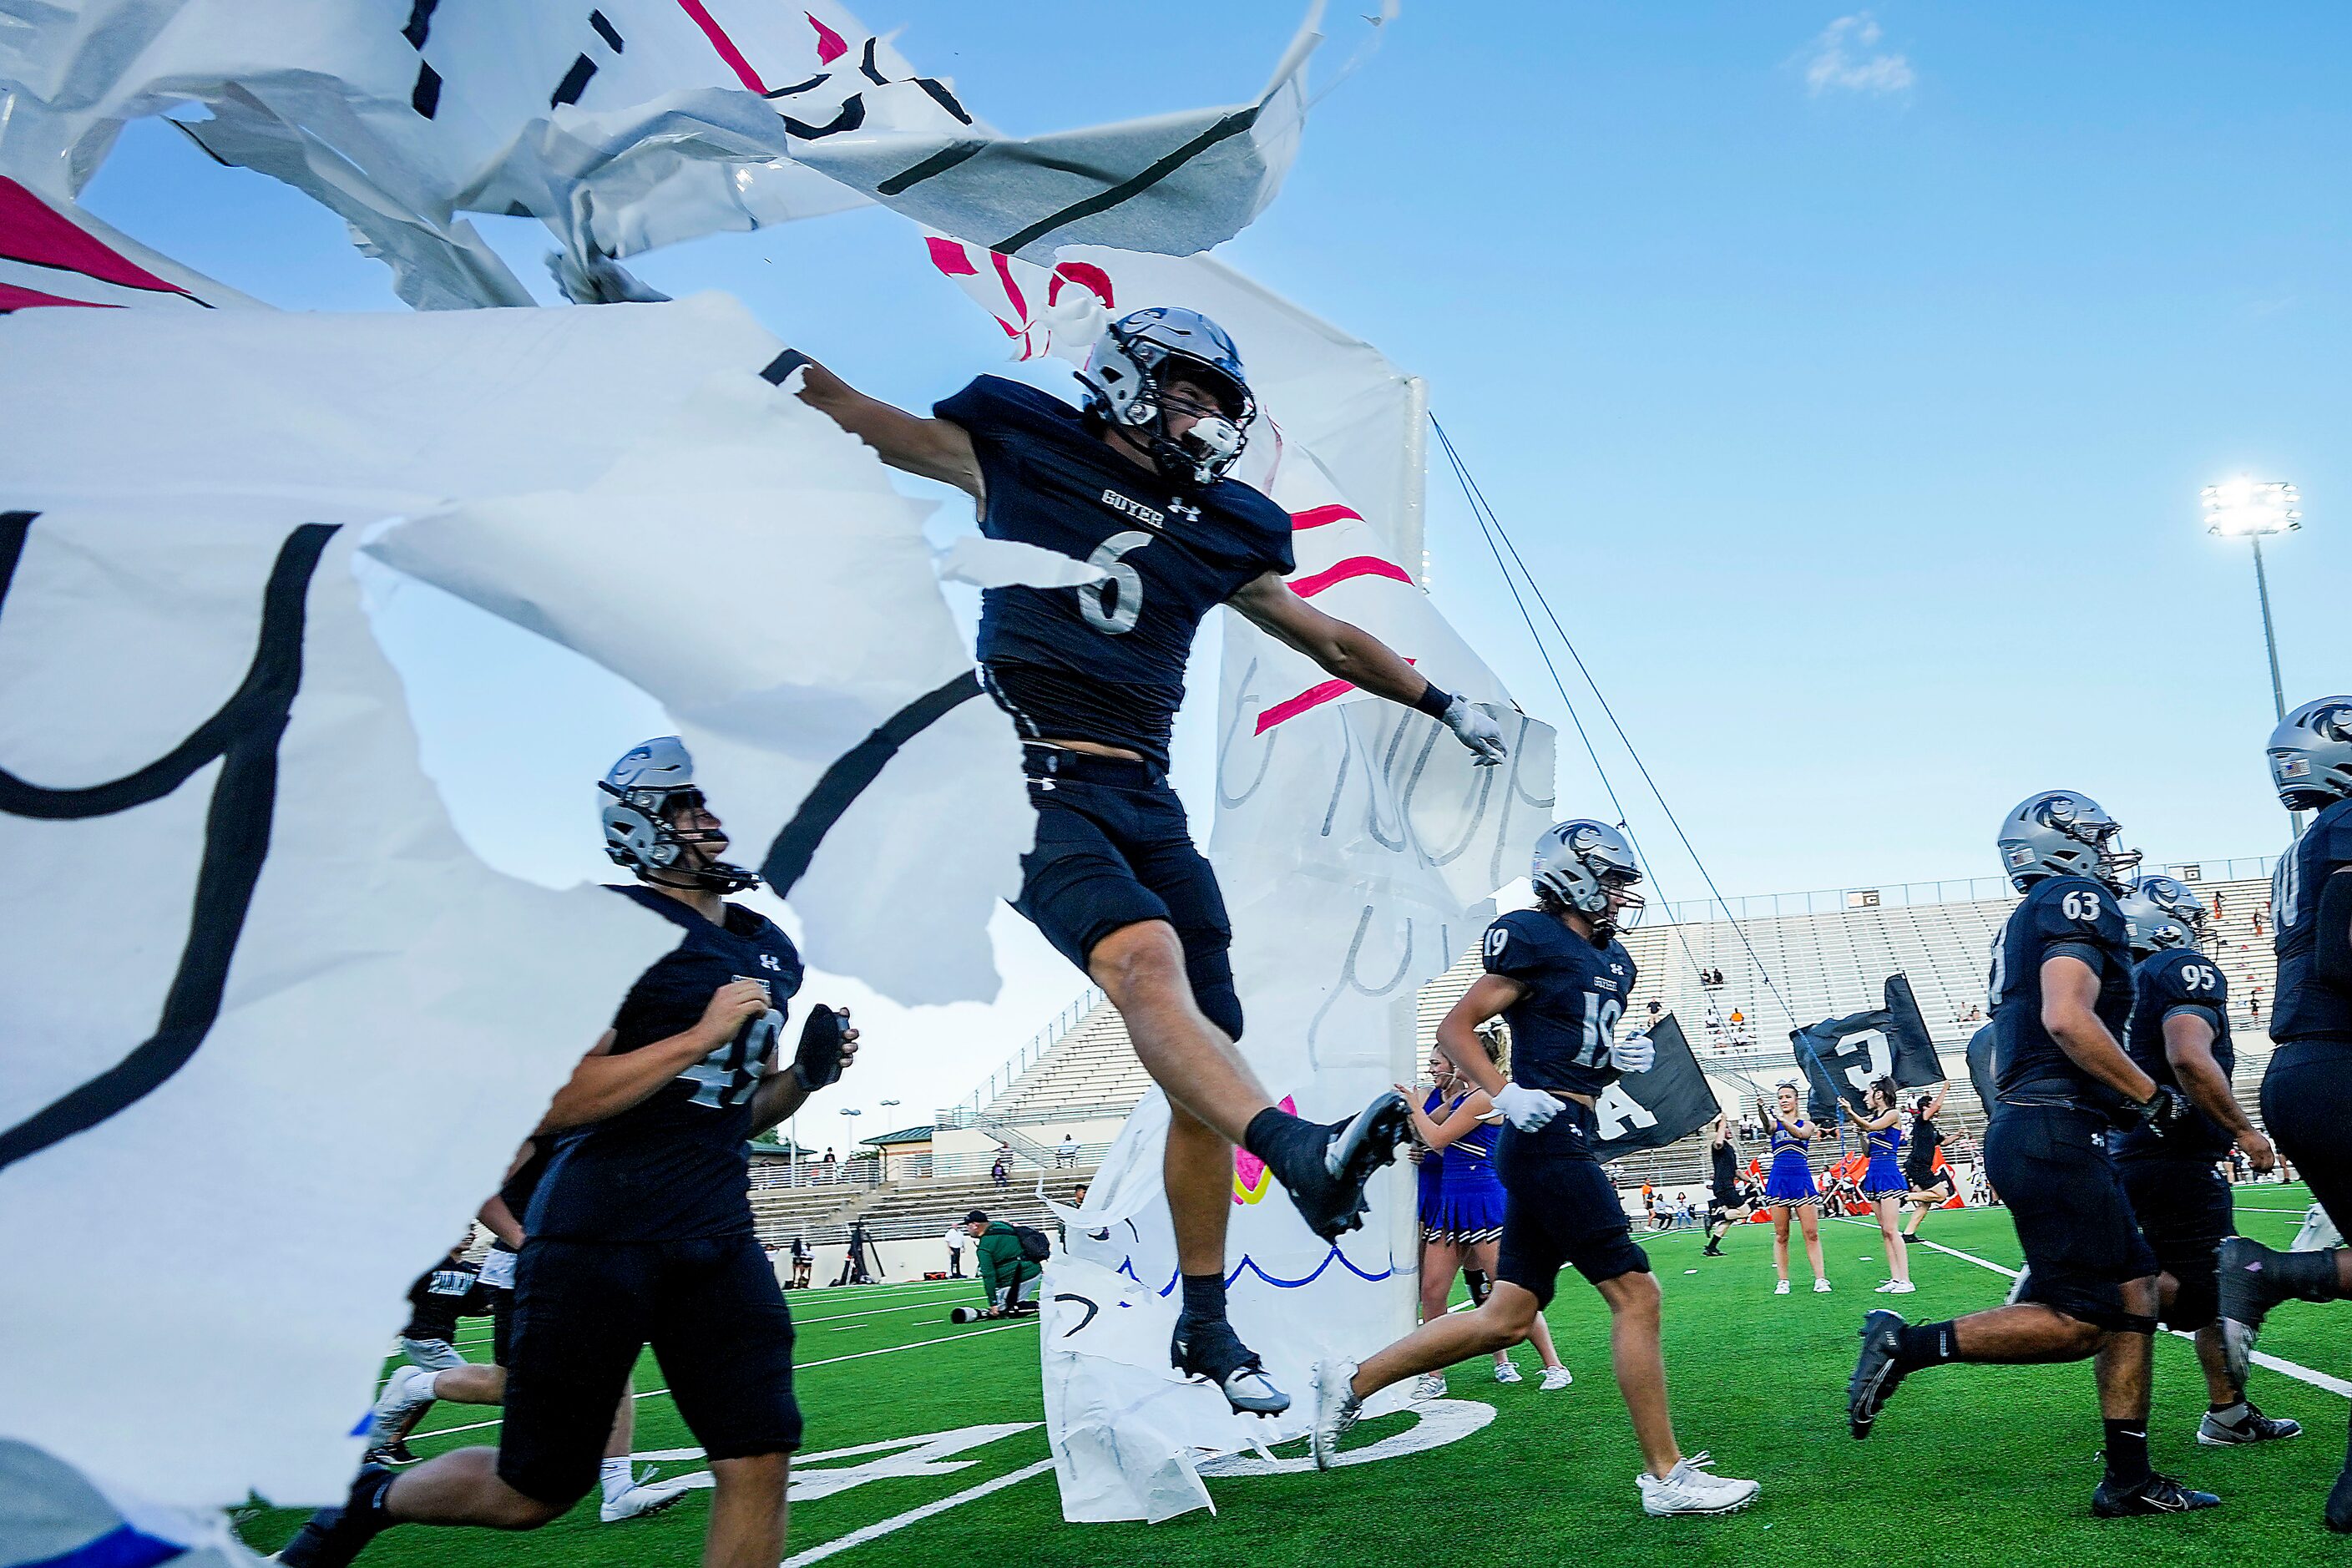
[2220, 695, 2352, 1533]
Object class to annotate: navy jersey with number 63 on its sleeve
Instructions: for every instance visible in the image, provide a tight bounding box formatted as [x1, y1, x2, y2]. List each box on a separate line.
[1990, 877, 2131, 1115]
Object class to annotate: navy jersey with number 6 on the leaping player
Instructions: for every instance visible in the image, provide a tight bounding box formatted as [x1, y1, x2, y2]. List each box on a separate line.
[932, 376, 1293, 769]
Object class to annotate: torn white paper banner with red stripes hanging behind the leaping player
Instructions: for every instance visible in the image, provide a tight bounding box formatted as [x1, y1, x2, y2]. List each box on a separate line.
[929, 245, 1552, 1519]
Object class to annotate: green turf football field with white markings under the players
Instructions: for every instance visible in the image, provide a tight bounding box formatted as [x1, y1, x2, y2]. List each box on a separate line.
[245, 1187, 2352, 1568]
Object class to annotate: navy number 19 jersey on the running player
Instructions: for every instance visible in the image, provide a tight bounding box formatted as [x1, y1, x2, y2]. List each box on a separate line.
[1479, 910, 1635, 1105]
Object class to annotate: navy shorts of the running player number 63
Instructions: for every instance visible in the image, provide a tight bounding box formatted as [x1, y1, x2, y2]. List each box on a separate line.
[1985, 1105, 2159, 1328]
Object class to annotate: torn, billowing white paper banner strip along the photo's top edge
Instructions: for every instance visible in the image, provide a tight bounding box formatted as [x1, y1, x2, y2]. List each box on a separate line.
[0, 0, 1345, 308]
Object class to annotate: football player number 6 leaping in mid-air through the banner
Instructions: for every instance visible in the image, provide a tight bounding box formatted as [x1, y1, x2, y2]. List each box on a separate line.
[790, 306, 1503, 1415]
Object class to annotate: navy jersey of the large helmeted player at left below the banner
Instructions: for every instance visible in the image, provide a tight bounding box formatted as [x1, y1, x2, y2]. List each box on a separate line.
[522, 886, 802, 1242]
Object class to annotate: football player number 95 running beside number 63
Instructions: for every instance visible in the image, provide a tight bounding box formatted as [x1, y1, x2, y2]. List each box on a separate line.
[2114, 877, 2303, 1448]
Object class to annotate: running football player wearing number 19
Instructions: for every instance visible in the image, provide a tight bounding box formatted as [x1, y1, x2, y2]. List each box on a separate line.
[1313, 821, 1762, 1516]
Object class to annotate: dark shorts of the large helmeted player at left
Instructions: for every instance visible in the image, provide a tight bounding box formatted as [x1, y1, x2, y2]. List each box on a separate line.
[498, 1234, 800, 1507]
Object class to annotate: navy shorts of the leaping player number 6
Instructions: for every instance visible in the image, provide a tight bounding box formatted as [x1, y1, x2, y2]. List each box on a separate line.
[1014, 746, 1242, 1039]
